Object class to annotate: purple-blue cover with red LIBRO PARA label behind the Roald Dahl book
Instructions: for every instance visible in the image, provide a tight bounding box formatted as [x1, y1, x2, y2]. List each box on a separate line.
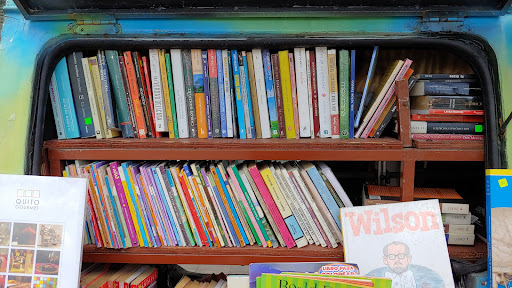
[249, 262, 359, 288]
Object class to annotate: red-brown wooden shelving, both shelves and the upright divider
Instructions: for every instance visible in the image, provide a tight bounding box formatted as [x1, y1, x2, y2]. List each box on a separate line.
[42, 46, 486, 265]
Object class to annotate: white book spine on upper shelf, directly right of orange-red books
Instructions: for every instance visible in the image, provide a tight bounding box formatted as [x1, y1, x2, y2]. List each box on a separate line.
[149, 49, 169, 132]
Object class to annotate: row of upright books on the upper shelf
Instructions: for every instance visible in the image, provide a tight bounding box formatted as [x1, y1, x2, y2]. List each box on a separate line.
[50, 47, 413, 139]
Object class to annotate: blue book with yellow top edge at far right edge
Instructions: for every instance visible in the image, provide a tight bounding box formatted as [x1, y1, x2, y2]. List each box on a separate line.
[485, 169, 512, 288]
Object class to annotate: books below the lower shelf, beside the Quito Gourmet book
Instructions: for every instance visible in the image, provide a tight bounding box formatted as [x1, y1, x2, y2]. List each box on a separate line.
[80, 263, 158, 288]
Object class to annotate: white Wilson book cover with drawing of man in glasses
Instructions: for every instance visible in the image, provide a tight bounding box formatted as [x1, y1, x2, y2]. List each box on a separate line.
[340, 199, 455, 288]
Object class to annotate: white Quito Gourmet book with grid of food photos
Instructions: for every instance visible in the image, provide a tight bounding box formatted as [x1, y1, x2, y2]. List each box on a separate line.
[0, 175, 87, 288]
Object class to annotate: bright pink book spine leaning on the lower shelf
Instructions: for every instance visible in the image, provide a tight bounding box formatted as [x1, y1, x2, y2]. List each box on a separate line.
[249, 165, 296, 248]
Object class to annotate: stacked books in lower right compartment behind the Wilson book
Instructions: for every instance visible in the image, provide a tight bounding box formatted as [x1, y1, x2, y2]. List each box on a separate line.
[363, 185, 475, 245]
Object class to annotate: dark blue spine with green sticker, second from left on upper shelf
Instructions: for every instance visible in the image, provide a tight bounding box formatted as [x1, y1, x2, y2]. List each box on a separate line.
[66, 52, 95, 138]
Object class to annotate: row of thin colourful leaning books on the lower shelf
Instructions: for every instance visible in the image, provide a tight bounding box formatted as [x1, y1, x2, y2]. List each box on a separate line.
[63, 161, 352, 248]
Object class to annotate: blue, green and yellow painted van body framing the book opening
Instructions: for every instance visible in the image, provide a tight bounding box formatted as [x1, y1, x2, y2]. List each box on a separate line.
[0, 0, 512, 174]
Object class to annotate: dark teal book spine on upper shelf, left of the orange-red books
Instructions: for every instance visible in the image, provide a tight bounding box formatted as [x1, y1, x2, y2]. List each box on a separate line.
[105, 50, 134, 138]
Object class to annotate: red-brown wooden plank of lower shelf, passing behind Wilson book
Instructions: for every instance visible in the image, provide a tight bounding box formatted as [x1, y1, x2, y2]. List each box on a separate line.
[82, 240, 487, 265]
